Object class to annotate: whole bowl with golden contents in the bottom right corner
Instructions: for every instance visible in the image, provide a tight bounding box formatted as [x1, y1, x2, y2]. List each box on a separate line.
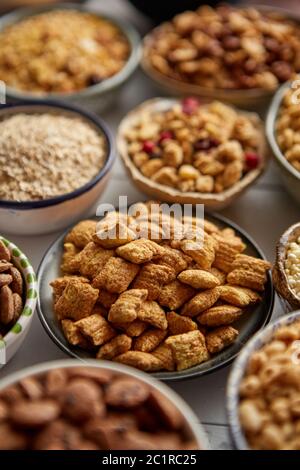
[227, 310, 300, 450]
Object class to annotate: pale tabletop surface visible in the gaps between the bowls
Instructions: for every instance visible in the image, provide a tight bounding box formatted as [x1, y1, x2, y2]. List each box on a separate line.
[0, 0, 299, 449]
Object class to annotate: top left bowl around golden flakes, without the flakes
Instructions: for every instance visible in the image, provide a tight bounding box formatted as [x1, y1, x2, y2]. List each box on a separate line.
[0, 3, 141, 112]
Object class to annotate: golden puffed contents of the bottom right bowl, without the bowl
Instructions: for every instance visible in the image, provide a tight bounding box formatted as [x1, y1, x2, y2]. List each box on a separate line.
[239, 320, 300, 450]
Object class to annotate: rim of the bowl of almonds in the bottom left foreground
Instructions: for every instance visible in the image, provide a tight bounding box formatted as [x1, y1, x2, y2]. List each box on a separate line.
[0, 359, 210, 450]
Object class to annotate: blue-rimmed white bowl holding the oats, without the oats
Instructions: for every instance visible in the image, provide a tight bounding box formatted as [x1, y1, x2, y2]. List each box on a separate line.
[0, 101, 115, 235]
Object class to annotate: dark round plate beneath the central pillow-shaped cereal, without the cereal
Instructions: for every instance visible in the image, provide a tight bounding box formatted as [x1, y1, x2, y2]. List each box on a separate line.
[37, 209, 274, 381]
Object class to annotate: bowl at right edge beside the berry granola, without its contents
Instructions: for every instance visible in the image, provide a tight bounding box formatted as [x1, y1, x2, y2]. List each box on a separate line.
[266, 82, 300, 204]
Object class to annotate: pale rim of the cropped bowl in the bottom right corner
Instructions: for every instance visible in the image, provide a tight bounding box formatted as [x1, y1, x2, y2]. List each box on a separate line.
[226, 310, 300, 450]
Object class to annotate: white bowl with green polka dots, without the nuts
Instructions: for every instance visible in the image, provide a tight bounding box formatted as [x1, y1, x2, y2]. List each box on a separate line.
[0, 235, 37, 367]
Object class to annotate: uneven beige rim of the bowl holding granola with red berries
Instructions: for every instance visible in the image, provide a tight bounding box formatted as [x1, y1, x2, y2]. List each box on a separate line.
[116, 97, 269, 206]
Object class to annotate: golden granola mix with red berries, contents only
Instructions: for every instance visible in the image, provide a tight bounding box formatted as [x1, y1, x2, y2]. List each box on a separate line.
[123, 97, 263, 193]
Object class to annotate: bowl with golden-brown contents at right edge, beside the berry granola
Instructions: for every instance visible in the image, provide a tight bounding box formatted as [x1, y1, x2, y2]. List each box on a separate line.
[266, 79, 300, 203]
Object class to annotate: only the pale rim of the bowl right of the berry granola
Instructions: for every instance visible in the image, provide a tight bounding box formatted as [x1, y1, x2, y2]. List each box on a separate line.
[266, 81, 300, 181]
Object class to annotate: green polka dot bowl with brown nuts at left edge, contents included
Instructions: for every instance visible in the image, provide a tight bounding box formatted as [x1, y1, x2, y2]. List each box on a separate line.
[0, 236, 37, 367]
